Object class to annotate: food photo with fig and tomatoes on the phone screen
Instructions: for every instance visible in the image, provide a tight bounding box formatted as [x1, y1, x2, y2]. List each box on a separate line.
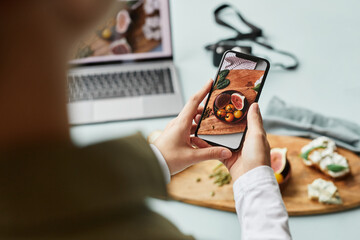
[198, 52, 265, 135]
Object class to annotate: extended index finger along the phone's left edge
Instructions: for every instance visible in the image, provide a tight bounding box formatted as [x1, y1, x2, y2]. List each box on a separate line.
[179, 80, 213, 123]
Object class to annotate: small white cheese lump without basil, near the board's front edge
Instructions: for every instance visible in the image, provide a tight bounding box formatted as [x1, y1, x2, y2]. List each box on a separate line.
[308, 178, 342, 204]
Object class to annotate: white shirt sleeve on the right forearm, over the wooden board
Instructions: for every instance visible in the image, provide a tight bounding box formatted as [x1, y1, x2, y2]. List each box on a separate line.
[233, 166, 291, 240]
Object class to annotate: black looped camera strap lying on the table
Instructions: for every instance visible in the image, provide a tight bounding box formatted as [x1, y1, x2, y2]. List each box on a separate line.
[205, 4, 299, 70]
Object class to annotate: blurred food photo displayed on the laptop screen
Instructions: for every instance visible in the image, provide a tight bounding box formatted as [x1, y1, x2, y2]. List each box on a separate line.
[72, 0, 166, 60]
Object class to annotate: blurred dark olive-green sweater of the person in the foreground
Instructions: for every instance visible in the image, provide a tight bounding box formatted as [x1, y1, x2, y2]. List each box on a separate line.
[0, 134, 192, 240]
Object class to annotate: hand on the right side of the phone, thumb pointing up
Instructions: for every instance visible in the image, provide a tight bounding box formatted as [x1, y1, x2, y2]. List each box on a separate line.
[194, 103, 270, 180]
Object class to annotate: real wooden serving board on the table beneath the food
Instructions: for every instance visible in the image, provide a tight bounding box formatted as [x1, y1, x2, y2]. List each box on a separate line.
[168, 135, 360, 216]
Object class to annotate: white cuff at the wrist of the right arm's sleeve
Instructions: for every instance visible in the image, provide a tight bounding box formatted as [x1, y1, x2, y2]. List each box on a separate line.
[233, 166, 277, 201]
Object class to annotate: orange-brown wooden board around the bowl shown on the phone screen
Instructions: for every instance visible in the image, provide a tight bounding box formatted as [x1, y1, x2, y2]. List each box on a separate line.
[198, 69, 264, 135]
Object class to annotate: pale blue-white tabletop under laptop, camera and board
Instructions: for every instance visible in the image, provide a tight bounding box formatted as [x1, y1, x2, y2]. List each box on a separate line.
[71, 0, 360, 239]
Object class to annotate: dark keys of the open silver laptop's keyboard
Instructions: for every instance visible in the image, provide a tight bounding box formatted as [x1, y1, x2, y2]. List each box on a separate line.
[68, 68, 174, 102]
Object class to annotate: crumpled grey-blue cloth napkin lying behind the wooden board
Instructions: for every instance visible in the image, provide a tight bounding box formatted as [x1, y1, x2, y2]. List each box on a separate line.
[264, 97, 360, 154]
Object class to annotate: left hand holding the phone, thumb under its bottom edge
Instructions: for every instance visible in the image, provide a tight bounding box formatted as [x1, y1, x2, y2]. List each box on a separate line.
[154, 80, 232, 175]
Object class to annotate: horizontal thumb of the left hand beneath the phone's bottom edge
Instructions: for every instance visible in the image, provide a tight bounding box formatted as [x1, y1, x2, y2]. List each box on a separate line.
[193, 147, 232, 161]
